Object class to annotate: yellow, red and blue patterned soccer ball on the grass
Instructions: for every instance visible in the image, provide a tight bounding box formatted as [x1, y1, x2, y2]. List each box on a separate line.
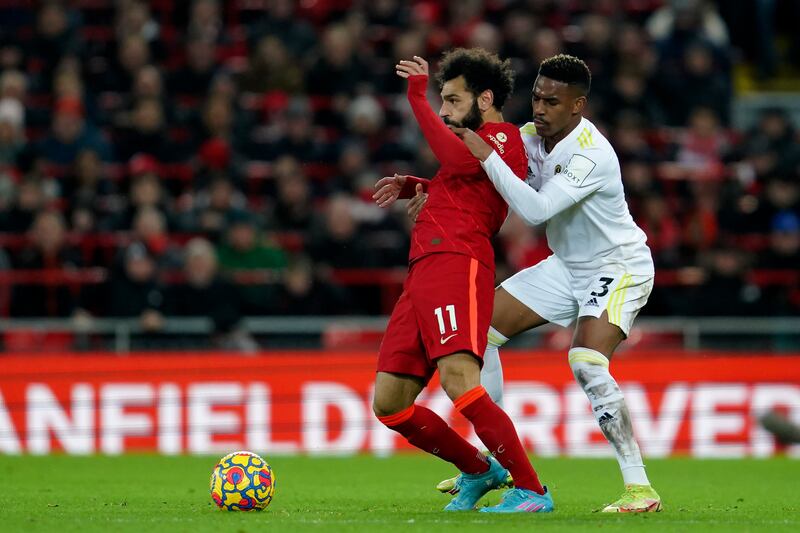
[211, 451, 275, 511]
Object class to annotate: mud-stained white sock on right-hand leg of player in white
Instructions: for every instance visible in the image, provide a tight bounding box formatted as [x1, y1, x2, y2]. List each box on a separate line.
[568, 348, 650, 485]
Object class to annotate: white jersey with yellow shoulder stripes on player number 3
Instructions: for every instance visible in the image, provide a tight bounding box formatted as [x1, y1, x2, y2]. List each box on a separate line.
[520, 118, 654, 275]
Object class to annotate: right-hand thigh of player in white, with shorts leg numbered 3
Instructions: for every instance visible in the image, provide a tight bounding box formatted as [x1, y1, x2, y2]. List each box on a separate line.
[572, 270, 653, 358]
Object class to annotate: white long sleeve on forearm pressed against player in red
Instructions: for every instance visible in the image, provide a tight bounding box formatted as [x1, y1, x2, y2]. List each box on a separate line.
[481, 151, 577, 226]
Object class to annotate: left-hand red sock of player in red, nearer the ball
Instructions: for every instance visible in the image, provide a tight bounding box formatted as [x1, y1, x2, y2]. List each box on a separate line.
[378, 404, 488, 479]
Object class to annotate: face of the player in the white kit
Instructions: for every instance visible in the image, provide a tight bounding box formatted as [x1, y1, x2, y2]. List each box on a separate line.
[532, 76, 585, 137]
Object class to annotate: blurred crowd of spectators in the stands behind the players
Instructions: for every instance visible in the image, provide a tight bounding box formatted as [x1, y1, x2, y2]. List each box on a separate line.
[0, 0, 800, 342]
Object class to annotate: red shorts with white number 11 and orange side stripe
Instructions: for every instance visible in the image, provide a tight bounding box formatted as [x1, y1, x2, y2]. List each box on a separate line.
[378, 253, 494, 380]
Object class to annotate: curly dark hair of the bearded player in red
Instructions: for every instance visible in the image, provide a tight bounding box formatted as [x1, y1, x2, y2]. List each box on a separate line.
[436, 48, 514, 110]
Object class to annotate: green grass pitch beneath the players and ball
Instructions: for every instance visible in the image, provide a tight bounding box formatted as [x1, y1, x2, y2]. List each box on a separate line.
[0, 454, 800, 533]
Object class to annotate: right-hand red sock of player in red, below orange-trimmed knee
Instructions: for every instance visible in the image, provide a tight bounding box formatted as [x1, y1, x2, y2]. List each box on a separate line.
[453, 386, 544, 494]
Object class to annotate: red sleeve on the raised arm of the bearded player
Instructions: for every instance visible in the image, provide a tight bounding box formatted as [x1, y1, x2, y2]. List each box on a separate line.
[408, 76, 479, 170]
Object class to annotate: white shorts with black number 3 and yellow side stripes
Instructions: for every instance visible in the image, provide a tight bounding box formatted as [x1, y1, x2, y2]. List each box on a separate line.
[500, 255, 653, 336]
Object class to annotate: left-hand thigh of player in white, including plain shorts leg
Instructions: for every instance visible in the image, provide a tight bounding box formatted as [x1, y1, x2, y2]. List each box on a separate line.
[500, 255, 578, 337]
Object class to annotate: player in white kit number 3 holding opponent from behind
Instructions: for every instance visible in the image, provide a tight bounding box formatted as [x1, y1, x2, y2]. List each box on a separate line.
[409, 54, 661, 512]
